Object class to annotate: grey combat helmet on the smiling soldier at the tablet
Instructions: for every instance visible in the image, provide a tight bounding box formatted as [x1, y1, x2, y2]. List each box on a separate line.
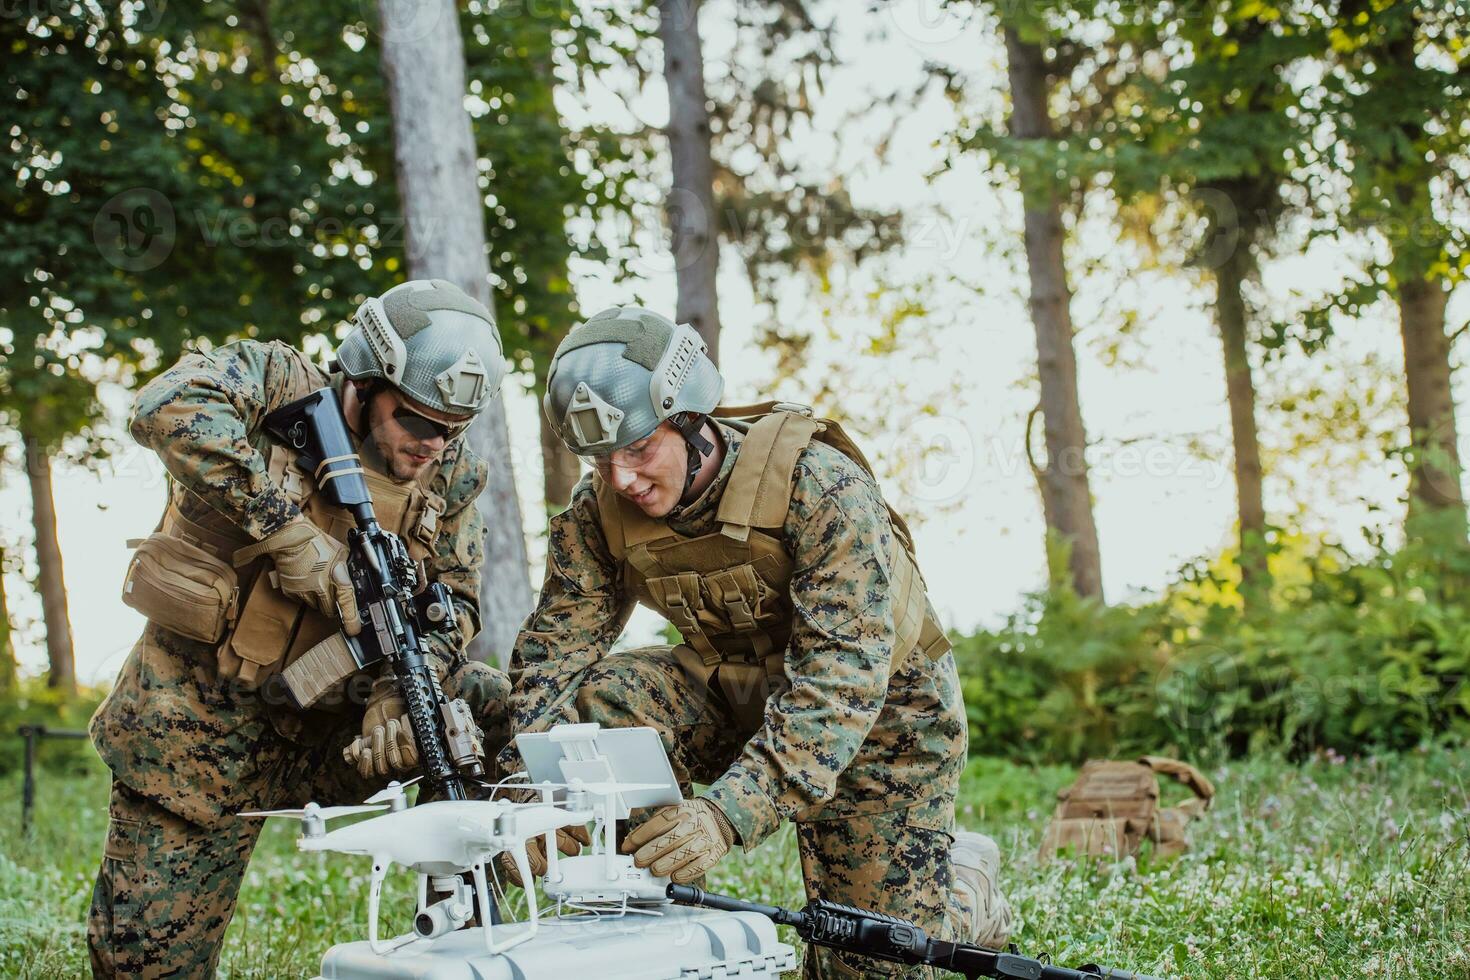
[541, 306, 725, 480]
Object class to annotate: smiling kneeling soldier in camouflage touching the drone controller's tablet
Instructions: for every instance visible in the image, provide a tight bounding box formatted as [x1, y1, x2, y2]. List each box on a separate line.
[503, 307, 1010, 977]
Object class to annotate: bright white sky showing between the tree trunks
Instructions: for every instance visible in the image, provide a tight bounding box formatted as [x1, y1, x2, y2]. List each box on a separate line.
[0, 0, 1470, 683]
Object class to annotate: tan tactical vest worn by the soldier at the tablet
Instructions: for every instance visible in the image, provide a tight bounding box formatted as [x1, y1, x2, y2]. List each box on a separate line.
[594, 401, 950, 729]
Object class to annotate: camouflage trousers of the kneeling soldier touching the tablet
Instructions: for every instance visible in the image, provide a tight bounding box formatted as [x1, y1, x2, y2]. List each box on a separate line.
[567, 646, 975, 979]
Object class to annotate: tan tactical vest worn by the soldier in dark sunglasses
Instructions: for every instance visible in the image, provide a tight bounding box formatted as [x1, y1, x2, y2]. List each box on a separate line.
[144, 445, 444, 689]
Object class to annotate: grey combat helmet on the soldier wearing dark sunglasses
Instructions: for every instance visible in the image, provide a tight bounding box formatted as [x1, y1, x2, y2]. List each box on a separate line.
[337, 279, 506, 414]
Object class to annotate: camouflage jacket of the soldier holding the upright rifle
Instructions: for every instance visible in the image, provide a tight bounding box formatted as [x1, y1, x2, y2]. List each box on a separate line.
[91, 341, 485, 823]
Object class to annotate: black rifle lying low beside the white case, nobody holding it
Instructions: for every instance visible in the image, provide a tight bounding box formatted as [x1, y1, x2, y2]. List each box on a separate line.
[669, 884, 1154, 980]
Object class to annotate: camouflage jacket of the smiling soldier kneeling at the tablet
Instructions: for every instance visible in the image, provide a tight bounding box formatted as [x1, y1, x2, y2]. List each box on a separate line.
[501, 425, 967, 848]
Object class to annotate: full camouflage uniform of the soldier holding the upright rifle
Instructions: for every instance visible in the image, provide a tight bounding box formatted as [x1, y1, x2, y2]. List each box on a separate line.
[88, 341, 509, 977]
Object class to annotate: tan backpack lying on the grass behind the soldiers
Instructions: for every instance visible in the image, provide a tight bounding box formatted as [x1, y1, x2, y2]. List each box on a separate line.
[1041, 755, 1214, 860]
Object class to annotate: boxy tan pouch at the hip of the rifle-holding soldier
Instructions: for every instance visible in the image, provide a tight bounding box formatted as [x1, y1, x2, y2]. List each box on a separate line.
[122, 532, 240, 644]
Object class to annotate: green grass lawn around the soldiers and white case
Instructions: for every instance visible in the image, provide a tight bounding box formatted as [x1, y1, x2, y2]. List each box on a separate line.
[0, 748, 1470, 980]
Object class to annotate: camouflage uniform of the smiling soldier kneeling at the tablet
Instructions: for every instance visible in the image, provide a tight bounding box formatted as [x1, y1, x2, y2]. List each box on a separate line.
[503, 423, 972, 977]
